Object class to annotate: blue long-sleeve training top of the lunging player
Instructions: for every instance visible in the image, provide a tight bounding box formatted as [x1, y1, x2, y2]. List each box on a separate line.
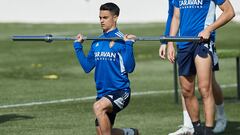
[74, 28, 135, 98]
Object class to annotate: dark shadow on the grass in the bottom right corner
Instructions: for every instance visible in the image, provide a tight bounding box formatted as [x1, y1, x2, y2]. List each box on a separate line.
[218, 121, 240, 135]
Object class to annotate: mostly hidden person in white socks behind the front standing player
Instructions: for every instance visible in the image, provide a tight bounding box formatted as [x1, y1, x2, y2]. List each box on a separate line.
[159, 0, 233, 135]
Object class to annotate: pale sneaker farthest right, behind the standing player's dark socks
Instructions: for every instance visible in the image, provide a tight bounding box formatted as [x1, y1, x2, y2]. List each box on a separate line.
[213, 117, 227, 133]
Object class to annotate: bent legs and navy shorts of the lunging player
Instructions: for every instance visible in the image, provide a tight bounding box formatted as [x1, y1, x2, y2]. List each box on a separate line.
[93, 90, 139, 135]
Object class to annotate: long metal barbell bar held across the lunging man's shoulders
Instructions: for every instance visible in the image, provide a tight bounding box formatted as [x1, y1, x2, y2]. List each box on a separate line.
[12, 34, 207, 43]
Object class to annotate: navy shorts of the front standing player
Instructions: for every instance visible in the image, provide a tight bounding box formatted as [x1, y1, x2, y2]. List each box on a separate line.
[177, 41, 219, 76]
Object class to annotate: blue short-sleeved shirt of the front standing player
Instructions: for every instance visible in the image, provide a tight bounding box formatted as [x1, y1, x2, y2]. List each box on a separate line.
[173, 0, 225, 48]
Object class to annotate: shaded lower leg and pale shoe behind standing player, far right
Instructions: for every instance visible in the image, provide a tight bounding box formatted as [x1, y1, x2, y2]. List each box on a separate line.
[212, 72, 227, 133]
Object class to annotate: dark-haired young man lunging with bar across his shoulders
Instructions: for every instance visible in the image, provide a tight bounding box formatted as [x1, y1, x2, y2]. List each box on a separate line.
[74, 3, 138, 135]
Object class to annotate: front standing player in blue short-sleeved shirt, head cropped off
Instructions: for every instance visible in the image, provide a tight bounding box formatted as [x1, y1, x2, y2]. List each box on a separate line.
[165, 0, 234, 135]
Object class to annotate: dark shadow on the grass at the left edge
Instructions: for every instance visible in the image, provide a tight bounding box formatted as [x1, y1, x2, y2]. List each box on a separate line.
[0, 114, 34, 124]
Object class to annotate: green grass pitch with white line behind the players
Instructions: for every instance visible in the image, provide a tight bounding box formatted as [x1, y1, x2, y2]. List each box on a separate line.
[0, 23, 240, 135]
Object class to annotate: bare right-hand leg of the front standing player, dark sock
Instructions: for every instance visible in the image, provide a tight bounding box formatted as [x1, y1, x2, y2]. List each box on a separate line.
[195, 54, 215, 134]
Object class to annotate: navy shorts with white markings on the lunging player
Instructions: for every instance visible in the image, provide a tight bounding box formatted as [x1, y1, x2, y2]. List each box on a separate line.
[95, 90, 131, 126]
